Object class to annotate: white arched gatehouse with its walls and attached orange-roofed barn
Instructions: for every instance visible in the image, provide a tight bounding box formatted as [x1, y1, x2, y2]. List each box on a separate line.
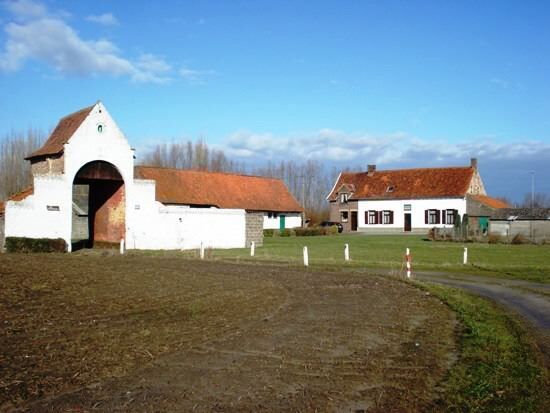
[0, 102, 302, 249]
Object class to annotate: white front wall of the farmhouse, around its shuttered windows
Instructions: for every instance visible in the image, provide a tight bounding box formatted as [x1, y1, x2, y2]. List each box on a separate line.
[357, 198, 466, 232]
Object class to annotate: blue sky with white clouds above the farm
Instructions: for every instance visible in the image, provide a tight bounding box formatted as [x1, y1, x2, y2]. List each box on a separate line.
[0, 0, 550, 200]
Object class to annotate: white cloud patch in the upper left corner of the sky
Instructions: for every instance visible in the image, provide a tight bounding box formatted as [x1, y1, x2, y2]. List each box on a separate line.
[0, 0, 187, 83]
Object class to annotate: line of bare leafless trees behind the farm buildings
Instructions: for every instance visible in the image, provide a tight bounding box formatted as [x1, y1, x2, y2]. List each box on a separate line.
[0, 129, 550, 222]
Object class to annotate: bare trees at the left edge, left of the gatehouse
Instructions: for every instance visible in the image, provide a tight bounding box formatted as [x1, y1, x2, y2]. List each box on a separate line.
[0, 129, 44, 200]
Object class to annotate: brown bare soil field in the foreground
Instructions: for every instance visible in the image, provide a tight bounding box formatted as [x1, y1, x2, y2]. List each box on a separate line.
[0, 251, 457, 412]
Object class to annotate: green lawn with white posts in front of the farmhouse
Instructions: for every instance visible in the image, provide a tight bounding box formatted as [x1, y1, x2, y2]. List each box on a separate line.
[213, 234, 550, 282]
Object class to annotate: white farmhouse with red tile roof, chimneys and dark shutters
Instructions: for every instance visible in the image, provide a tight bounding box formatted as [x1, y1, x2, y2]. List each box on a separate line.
[327, 159, 503, 233]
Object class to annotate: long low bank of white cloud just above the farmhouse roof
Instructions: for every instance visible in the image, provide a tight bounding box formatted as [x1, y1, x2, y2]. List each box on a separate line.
[222, 129, 550, 166]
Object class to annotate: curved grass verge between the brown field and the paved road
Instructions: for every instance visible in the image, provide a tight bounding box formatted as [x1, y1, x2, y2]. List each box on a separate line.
[421, 284, 550, 412]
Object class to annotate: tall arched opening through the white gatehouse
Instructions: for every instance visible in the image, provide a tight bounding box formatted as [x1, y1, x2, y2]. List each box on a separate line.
[71, 161, 126, 248]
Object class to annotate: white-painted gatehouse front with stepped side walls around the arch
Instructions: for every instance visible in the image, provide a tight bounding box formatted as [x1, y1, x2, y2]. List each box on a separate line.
[5, 102, 250, 249]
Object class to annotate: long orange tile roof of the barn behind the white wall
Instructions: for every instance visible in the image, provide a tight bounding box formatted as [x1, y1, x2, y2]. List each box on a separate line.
[135, 166, 302, 212]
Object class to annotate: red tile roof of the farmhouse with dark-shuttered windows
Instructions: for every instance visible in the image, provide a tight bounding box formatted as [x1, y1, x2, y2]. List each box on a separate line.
[328, 166, 475, 201]
